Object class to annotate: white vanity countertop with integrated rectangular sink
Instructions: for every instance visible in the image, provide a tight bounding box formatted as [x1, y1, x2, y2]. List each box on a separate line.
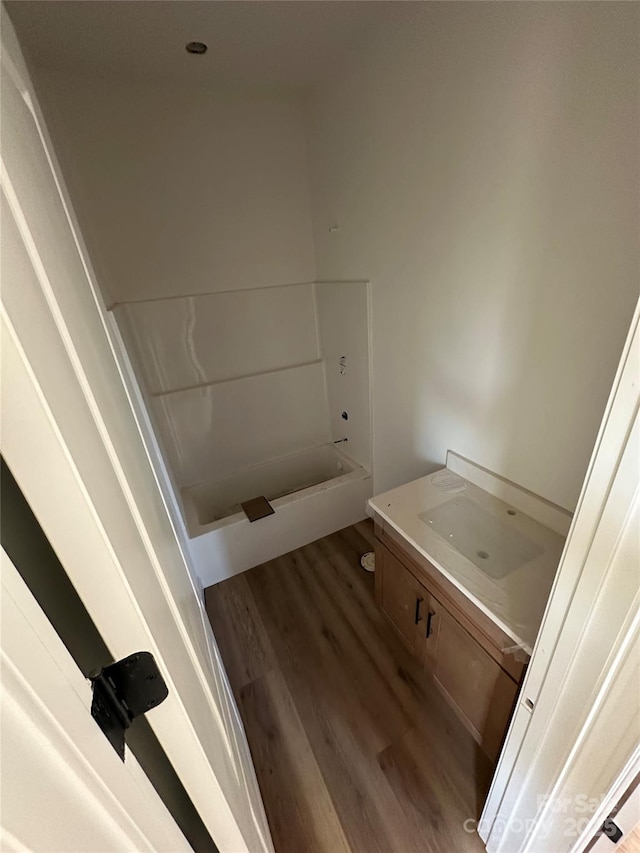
[369, 468, 570, 654]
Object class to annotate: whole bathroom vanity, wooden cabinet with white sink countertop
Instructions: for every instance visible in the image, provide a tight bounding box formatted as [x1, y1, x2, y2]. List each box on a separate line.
[369, 453, 571, 760]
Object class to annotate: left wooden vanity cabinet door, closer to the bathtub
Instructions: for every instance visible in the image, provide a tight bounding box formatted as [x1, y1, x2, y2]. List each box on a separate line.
[376, 547, 429, 660]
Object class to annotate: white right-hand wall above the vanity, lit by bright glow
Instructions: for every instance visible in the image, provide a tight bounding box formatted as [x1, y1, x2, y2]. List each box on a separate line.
[309, 3, 640, 509]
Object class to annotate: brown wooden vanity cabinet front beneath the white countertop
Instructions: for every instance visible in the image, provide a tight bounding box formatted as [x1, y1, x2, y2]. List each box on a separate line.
[376, 527, 525, 760]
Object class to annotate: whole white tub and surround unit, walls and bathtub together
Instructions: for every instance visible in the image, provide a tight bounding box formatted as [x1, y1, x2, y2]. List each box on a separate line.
[114, 281, 371, 585]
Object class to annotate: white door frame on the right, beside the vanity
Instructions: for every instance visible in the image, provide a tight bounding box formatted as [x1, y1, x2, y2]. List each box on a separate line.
[479, 301, 640, 853]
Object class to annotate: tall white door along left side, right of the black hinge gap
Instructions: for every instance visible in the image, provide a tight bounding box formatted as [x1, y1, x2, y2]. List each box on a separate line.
[1, 9, 273, 853]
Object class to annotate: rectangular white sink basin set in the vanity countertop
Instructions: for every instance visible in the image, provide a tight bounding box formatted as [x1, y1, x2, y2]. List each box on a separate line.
[418, 495, 544, 580]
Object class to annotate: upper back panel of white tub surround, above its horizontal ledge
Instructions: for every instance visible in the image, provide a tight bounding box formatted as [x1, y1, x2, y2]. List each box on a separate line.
[116, 284, 319, 394]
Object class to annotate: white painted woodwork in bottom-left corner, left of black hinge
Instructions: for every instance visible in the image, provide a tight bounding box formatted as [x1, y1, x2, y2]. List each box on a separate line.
[0, 550, 191, 853]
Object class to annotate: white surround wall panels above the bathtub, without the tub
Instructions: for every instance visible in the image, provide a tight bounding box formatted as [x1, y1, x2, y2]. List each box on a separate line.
[115, 282, 371, 488]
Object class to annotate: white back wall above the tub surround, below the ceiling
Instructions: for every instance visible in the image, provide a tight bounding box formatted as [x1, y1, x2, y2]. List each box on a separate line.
[36, 70, 315, 302]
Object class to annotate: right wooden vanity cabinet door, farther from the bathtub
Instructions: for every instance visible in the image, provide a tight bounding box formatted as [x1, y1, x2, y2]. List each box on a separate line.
[425, 598, 518, 759]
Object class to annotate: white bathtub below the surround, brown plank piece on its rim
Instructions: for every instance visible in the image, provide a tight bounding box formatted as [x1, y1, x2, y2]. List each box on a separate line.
[181, 444, 372, 587]
